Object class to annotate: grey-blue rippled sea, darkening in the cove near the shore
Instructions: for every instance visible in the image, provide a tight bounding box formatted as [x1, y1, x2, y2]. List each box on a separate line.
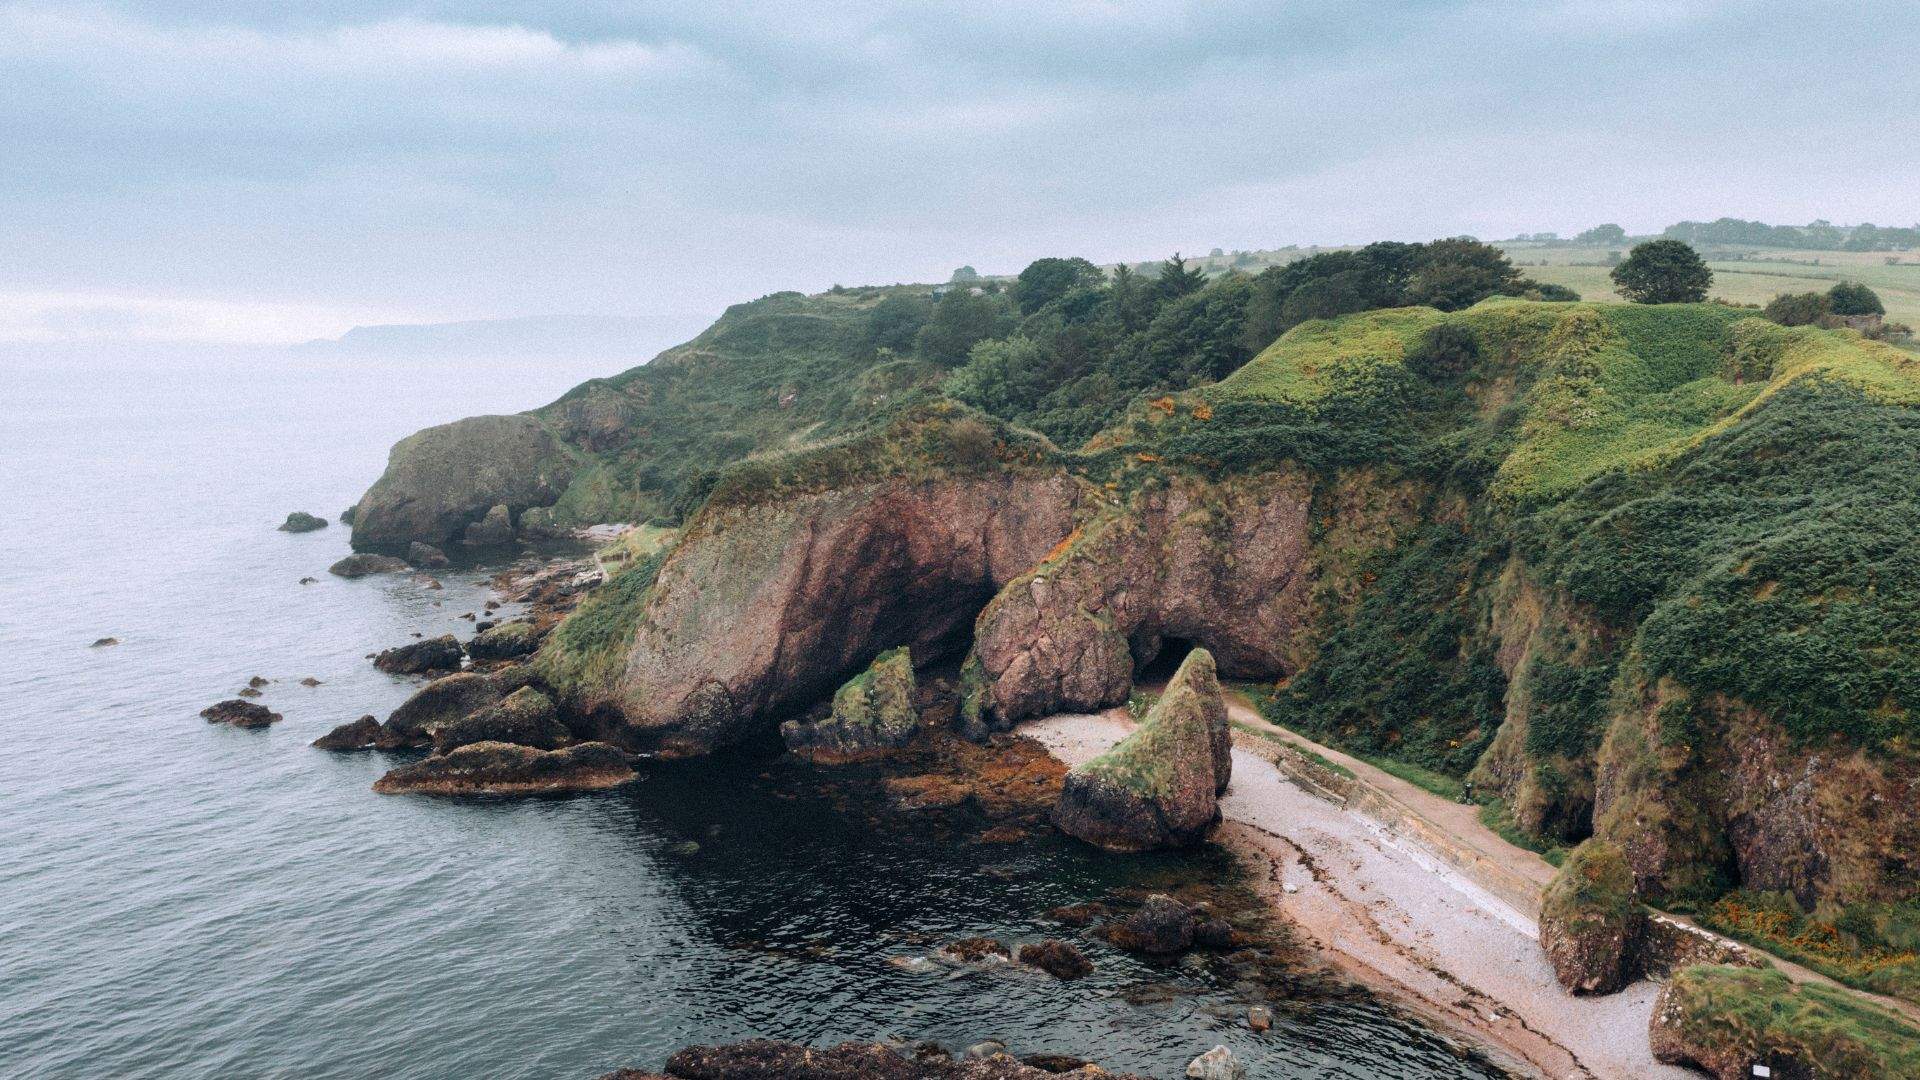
[0, 348, 1494, 1078]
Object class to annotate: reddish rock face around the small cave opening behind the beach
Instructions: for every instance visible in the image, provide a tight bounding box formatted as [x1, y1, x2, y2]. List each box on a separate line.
[970, 471, 1311, 728]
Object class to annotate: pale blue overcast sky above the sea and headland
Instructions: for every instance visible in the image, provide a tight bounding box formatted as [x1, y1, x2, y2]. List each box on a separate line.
[0, 0, 1920, 344]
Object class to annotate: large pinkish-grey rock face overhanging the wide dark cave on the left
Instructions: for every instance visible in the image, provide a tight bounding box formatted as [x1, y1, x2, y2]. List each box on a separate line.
[612, 473, 1083, 753]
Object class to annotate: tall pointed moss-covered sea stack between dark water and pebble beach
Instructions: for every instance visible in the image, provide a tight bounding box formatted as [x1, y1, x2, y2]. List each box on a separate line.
[1054, 650, 1233, 851]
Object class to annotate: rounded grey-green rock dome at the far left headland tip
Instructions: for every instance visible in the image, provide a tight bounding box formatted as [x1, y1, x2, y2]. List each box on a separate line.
[353, 415, 574, 550]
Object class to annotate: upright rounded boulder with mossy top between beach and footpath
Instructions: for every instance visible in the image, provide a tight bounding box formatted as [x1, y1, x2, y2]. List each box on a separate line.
[1540, 840, 1645, 994]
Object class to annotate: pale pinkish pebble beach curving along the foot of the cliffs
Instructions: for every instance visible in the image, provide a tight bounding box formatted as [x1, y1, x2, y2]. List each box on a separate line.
[1020, 711, 1695, 1080]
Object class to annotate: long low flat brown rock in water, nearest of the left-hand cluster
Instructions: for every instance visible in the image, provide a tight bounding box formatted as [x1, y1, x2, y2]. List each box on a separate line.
[372, 742, 636, 796]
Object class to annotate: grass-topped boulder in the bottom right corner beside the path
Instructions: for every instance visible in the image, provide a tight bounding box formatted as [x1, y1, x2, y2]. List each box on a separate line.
[1663, 967, 1920, 1078]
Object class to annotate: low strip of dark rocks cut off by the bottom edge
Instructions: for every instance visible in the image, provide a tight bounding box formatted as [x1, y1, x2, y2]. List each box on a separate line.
[637, 1040, 1139, 1080]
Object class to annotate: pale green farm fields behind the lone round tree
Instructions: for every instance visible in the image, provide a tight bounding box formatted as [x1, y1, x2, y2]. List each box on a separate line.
[1503, 244, 1920, 327]
